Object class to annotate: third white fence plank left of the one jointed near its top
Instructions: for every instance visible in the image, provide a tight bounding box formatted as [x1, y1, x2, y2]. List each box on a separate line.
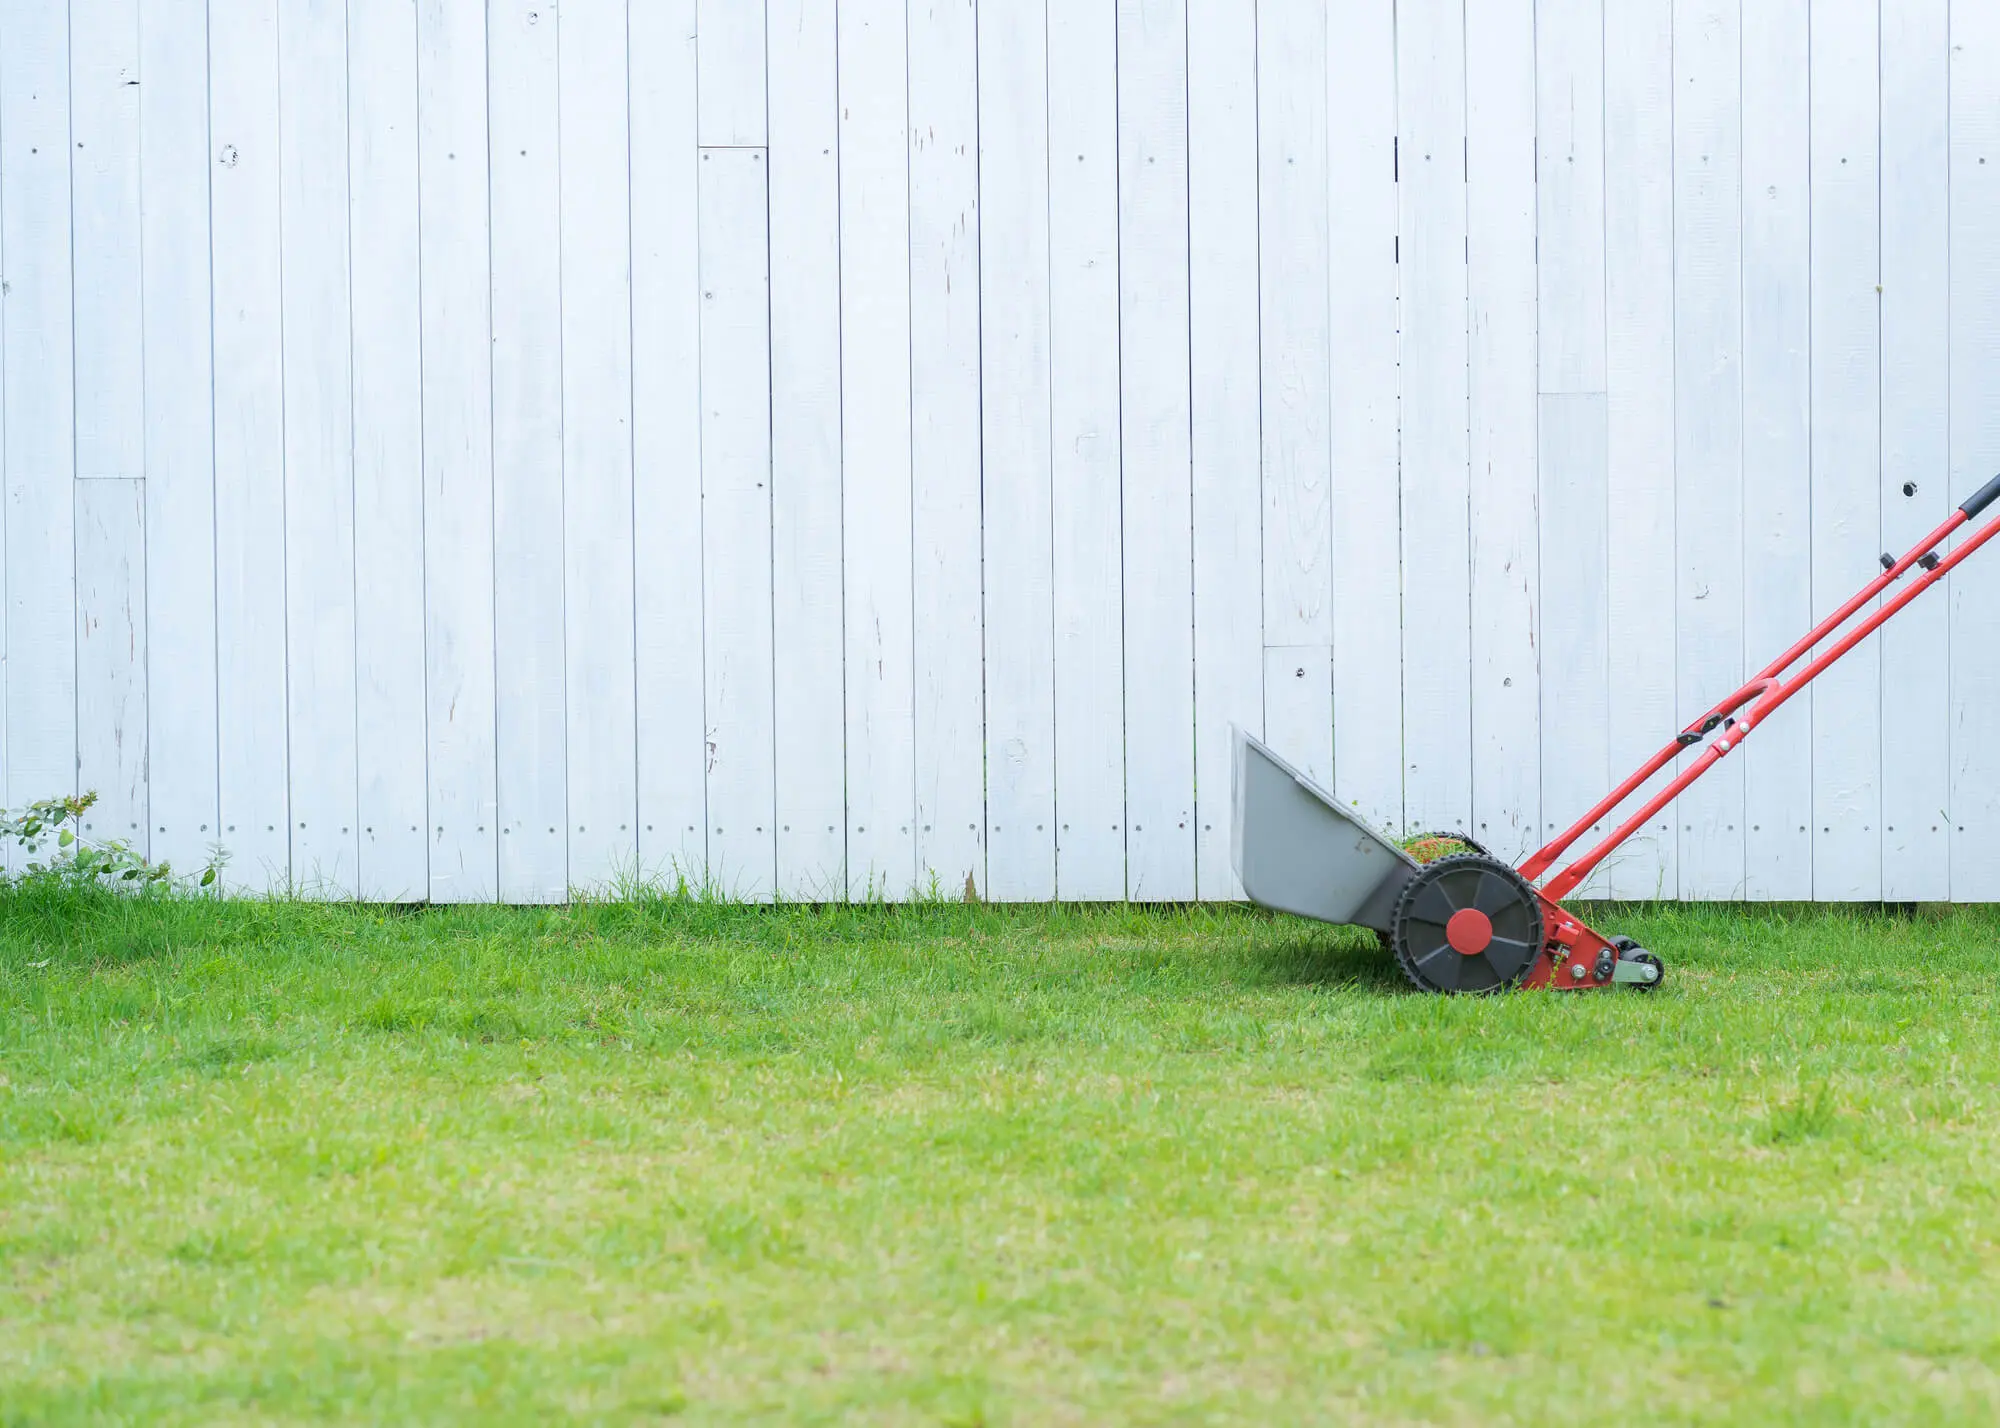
[488, 0, 568, 902]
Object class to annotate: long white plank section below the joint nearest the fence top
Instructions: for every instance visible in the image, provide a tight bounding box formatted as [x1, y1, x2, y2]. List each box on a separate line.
[700, 148, 778, 900]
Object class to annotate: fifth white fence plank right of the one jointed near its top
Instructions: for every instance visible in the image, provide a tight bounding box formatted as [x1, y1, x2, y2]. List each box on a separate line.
[1048, 4, 1128, 900]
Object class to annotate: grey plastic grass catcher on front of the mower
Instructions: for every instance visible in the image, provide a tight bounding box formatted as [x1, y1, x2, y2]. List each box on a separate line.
[1230, 730, 1420, 932]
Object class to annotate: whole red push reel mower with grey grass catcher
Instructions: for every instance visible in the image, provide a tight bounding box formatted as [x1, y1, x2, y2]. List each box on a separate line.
[1232, 476, 2000, 992]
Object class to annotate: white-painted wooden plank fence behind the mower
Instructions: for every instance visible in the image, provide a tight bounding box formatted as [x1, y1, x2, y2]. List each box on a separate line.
[0, 0, 2000, 900]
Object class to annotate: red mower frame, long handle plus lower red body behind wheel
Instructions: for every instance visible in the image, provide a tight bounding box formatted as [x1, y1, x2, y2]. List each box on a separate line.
[1520, 476, 2000, 992]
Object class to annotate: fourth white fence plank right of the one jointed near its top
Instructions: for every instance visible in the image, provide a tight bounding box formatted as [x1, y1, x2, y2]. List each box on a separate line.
[978, 4, 1056, 900]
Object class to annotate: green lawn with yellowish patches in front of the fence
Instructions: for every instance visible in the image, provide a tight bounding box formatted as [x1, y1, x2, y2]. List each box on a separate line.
[0, 892, 2000, 1426]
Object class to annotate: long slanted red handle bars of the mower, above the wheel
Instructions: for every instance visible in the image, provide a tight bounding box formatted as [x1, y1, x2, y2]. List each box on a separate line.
[1520, 502, 2000, 900]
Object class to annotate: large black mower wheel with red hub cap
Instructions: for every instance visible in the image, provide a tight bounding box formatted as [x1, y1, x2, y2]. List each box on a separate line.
[1388, 852, 1542, 992]
